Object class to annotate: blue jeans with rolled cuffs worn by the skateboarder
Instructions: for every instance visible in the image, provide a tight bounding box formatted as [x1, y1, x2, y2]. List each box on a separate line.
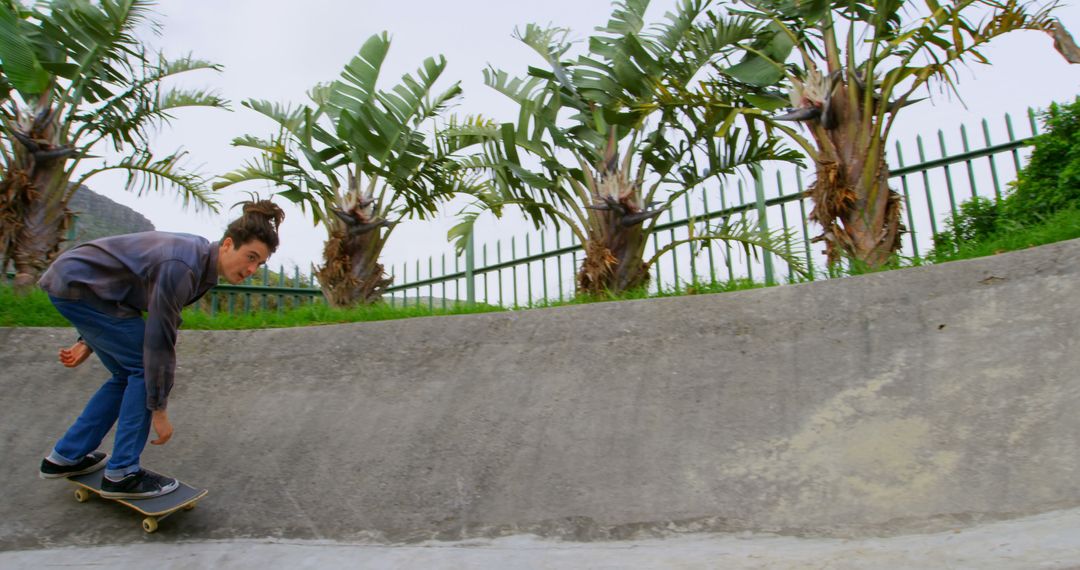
[49, 296, 152, 479]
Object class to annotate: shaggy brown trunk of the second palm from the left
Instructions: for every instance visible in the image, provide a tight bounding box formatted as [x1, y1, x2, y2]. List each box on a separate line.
[318, 227, 393, 308]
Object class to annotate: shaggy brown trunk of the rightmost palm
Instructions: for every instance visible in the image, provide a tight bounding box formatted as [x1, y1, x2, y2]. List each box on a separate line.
[807, 82, 905, 269]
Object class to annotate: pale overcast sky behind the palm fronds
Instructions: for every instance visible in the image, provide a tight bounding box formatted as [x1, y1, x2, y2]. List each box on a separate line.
[82, 0, 1080, 271]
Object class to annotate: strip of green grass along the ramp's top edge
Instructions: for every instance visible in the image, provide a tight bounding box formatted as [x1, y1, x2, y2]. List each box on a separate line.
[8, 208, 1080, 330]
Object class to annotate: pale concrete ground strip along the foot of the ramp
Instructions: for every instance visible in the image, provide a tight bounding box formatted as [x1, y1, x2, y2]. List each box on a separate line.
[6, 510, 1080, 570]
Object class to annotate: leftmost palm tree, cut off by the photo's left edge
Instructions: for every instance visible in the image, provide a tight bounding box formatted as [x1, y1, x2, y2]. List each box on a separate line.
[0, 0, 226, 291]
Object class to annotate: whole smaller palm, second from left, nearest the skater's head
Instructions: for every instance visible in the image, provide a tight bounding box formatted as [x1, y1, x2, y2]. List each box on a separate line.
[214, 32, 468, 307]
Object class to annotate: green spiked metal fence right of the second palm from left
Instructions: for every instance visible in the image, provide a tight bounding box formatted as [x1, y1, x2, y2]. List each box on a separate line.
[388, 109, 1038, 308]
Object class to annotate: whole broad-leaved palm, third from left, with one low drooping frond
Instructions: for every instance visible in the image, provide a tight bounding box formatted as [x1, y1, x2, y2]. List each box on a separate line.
[450, 0, 800, 295]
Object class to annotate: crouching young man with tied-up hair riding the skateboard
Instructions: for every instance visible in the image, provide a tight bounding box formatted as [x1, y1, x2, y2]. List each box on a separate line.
[39, 200, 285, 499]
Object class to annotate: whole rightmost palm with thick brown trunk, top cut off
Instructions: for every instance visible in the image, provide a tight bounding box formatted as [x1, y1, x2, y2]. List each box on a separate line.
[712, 0, 1080, 268]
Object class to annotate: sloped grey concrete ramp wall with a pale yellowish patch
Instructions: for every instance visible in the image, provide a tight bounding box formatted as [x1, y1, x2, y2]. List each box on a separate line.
[0, 242, 1080, 549]
